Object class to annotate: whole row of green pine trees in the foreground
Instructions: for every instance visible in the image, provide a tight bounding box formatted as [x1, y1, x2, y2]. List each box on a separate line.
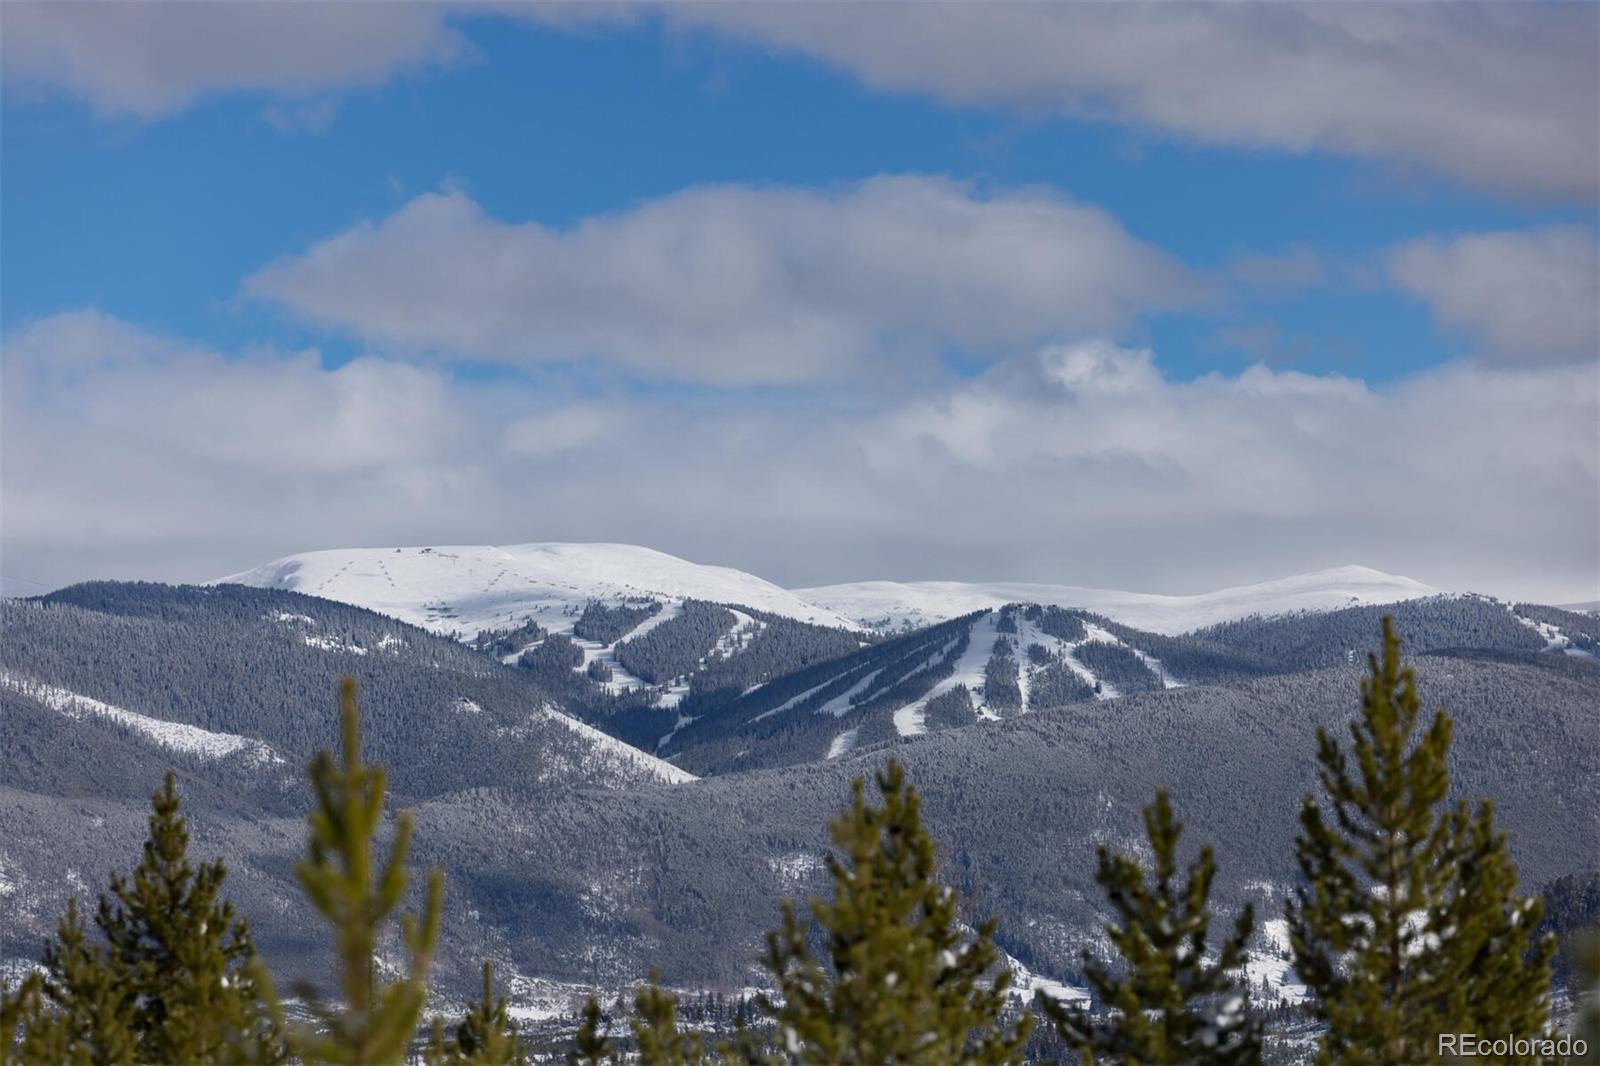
[0, 618, 1600, 1066]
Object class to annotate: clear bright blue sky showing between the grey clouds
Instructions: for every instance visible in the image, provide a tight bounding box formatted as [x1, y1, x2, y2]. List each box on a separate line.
[9, 12, 1594, 379]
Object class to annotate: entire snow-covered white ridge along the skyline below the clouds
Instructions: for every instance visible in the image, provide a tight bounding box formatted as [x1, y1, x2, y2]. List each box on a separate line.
[219, 543, 1440, 635]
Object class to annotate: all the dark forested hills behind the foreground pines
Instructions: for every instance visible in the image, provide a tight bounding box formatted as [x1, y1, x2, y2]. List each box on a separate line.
[0, 586, 1600, 1004]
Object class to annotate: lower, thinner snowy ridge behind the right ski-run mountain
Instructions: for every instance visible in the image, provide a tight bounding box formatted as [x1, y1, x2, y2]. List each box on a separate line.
[795, 567, 1440, 634]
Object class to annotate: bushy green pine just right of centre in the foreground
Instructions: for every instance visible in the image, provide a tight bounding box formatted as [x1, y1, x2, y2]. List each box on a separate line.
[760, 759, 1032, 1066]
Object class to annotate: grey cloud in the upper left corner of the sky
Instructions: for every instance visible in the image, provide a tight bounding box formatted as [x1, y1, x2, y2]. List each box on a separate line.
[0, 0, 469, 120]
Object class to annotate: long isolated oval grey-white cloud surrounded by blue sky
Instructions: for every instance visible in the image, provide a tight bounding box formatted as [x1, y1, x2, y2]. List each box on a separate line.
[246, 178, 1203, 384]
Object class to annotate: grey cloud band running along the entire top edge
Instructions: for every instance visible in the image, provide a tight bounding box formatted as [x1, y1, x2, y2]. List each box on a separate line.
[3, 2, 1600, 200]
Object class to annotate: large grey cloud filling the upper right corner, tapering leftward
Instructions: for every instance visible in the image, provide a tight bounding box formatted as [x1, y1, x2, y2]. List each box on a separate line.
[669, 3, 1600, 200]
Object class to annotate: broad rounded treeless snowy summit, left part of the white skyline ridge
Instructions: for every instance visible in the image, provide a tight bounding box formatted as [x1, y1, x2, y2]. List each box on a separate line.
[218, 544, 858, 635]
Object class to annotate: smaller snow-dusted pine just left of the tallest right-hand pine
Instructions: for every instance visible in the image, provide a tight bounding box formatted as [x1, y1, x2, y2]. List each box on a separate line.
[1038, 791, 1261, 1066]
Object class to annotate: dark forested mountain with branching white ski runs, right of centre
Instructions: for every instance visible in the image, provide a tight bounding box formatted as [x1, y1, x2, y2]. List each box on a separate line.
[646, 595, 1595, 775]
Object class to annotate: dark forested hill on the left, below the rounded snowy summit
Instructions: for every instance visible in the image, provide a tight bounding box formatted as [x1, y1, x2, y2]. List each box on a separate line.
[0, 583, 694, 802]
